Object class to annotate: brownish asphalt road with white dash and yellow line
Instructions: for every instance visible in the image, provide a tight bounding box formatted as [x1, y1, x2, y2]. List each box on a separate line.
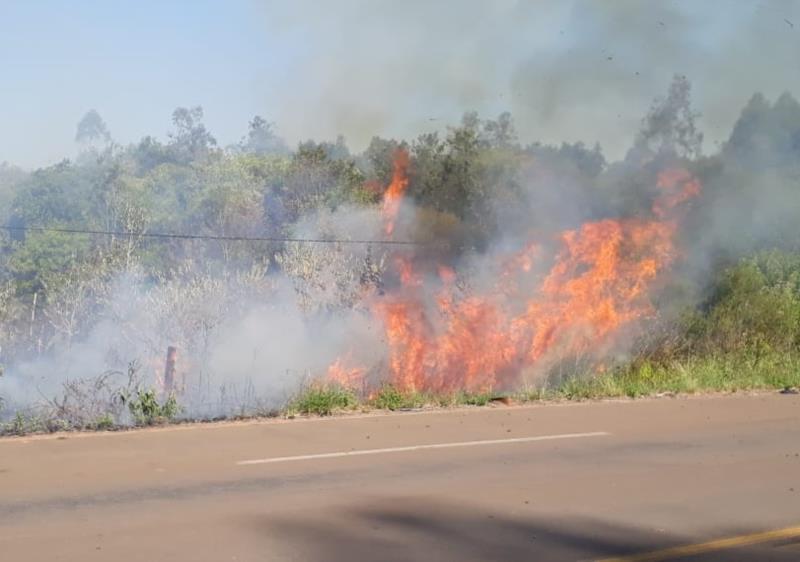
[0, 394, 800, 562]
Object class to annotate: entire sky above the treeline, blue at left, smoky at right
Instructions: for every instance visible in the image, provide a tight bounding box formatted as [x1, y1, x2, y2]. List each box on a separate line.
[0, 0, 800, 167]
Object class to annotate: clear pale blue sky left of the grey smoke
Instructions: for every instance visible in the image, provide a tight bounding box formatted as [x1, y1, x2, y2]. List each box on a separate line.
[0, 0, 276, 165]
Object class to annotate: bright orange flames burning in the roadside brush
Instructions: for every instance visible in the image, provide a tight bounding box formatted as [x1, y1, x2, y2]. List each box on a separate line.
[329, 160, 700, 391]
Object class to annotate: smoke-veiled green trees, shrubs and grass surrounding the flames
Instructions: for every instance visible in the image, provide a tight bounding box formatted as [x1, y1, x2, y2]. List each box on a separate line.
[0, 78, 800, 433]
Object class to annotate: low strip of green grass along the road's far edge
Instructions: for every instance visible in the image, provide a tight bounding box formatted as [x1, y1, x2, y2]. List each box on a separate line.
[0, 352, 800, 436]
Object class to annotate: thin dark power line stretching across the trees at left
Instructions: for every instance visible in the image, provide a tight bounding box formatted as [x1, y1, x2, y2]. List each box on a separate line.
[0, 224, 430, 246]
